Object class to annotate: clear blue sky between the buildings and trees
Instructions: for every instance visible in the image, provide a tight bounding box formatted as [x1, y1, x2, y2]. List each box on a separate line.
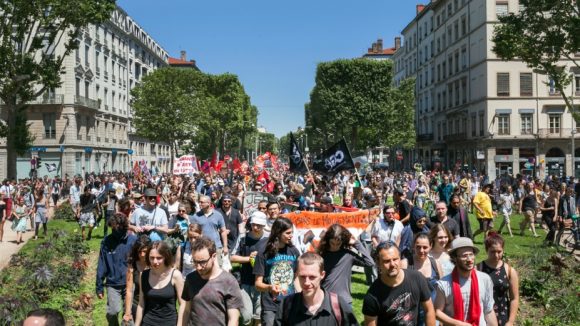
[117, 0, 428, 137]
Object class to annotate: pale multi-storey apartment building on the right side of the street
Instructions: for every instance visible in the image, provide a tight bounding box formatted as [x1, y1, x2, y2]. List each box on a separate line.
[393, 0, 580, 179]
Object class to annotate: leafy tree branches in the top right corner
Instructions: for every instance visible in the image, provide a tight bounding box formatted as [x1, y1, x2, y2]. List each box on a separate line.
[492, 0, 580, 117]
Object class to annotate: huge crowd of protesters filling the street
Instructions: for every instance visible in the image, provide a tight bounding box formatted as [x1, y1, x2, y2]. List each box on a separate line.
[0, 169, 580, 326]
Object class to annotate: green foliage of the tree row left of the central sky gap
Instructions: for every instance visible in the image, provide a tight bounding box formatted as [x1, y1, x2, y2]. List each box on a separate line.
[131, 67, 257, 157]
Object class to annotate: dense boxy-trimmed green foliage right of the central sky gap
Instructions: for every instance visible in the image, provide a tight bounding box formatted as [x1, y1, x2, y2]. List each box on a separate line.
[305, 59, 415, 151]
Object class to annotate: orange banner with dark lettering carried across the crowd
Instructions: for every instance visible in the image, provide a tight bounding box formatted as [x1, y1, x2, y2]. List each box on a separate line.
[282, 209, 379, 230]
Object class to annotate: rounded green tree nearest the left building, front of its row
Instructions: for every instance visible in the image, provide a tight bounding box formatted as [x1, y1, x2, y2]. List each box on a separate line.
[131, 67, 208, 166]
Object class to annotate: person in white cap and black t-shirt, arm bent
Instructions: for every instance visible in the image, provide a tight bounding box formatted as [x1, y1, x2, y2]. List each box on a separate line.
[230, 211, 267, 325]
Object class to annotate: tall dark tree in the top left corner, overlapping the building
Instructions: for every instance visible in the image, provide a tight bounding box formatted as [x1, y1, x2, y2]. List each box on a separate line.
[0, 0, 115, 177]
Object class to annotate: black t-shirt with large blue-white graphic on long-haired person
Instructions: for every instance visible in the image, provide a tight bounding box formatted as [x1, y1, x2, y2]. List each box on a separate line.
[254, 244, 300, 311]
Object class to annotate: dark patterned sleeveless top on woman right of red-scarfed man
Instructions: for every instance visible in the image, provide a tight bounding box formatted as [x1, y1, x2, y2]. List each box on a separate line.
[481, 262, 510, 326]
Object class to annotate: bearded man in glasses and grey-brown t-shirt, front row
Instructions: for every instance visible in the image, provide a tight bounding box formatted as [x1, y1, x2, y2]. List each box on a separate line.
[179, 236, 243, 326]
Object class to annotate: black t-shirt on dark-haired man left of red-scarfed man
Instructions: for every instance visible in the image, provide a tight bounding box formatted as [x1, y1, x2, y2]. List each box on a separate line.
[362, 270, 431, 326]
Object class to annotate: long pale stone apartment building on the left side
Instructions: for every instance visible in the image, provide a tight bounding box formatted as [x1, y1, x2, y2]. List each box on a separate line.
[0, 7, 170, 178]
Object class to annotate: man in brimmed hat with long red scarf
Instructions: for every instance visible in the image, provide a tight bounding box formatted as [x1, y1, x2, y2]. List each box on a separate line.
[435, 237, 497, 326]
